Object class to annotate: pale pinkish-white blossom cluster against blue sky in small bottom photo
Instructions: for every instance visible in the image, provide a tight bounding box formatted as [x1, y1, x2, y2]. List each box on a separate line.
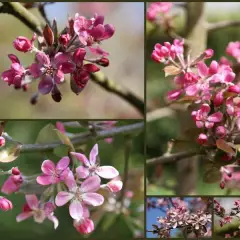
[148, 198, 212, 238]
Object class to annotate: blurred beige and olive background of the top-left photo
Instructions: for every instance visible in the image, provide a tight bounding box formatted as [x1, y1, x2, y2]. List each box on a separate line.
[0, 2, 144, 119]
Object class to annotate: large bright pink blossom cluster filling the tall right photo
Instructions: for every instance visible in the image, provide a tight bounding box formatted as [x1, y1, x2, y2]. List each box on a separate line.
[152, 39, 240, 188]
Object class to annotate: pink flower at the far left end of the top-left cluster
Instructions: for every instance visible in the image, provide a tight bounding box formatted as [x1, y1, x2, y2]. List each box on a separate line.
[1, 54, 26, 88]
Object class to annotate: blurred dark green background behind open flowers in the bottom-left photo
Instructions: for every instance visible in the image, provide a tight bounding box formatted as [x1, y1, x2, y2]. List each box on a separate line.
[0, 120, 144, 240]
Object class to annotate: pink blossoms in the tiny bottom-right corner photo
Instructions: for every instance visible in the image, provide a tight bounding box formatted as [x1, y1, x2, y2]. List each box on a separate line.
[214, 199, 240, 238]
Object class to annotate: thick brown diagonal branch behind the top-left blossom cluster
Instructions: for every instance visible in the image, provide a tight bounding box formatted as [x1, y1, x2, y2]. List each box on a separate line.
[0, 2, 145, 115]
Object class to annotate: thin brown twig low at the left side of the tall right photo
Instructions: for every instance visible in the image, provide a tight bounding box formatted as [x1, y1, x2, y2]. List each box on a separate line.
[147, 151, 200, 165]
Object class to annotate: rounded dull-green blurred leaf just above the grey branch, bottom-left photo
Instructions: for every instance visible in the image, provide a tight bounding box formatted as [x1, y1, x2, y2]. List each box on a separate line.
[36, 123, 59, 143]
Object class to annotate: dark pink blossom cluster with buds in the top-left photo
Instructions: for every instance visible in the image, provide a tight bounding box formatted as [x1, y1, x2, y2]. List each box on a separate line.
[1, 14, 115, 104]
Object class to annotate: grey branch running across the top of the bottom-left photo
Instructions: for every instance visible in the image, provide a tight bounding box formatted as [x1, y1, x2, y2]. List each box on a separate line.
[20, 122, 144, 153]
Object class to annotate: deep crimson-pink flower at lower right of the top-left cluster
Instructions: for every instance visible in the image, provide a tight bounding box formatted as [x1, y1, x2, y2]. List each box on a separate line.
[72, 48, 100, 90]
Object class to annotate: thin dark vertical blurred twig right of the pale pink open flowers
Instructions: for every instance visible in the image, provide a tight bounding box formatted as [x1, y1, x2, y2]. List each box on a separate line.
[119, 136, 132, 208]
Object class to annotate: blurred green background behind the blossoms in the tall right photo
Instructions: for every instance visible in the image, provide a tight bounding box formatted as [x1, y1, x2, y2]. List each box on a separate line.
[146, 2, 240, 195]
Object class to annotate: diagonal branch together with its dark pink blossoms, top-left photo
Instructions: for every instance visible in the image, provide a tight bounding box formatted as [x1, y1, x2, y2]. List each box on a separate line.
[0, 2, 144, 115]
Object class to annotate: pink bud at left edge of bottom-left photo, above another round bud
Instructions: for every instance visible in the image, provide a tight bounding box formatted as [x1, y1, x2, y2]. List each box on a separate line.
[1, 174, 23, 194]
